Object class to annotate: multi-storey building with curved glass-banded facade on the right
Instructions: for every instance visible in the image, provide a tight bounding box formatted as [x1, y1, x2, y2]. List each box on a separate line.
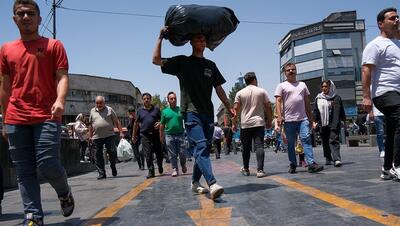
[279, 11, 366, 117]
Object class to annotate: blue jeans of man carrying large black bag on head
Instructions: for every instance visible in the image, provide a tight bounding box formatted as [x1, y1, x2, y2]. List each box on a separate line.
[183, 112, 216, 185]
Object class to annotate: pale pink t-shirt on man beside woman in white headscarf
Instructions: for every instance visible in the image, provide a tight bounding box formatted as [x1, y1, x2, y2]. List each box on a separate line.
[275, 81, 310, 122]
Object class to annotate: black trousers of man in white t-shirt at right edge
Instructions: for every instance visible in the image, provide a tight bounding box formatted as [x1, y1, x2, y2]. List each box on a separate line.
[373, 91, 400, 170]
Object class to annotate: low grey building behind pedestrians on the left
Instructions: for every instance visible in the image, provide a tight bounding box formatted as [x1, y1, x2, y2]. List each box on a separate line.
[63, 74, 142, 126]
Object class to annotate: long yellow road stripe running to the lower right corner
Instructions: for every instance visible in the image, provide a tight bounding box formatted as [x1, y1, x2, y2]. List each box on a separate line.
[267, 176, 400, 225]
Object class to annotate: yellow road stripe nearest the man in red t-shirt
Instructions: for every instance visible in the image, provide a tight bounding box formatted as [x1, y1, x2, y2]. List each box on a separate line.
[85, 178, 155, 226]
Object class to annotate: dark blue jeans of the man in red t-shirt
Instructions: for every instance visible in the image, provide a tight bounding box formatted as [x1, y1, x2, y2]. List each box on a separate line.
[6, 122, 69, 219]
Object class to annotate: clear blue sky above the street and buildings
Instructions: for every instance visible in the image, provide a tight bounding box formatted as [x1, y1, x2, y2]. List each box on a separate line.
[0, 0, 400, 116]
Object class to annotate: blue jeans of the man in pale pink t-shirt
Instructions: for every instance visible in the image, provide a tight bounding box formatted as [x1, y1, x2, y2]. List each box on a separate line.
[285, 119, 314, 166]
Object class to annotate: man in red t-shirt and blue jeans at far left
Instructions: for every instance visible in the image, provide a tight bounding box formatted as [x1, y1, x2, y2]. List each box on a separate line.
[0, 0, 74, 225]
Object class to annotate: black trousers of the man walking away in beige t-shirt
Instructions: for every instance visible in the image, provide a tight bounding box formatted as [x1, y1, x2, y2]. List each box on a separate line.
[240, 126, 265, 171]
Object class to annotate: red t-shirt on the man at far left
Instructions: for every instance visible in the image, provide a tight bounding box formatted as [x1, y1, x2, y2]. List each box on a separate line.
[0, 37, 68, 125]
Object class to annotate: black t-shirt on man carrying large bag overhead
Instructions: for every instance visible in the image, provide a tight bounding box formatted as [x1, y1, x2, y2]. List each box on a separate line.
[161, 55, 225, 116]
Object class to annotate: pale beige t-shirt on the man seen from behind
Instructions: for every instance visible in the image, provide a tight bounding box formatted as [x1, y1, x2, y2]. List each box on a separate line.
[235, 85, 270, 129]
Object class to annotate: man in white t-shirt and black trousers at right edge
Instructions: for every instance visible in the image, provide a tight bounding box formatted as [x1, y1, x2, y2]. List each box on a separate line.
[362, 8, 400, 179]
